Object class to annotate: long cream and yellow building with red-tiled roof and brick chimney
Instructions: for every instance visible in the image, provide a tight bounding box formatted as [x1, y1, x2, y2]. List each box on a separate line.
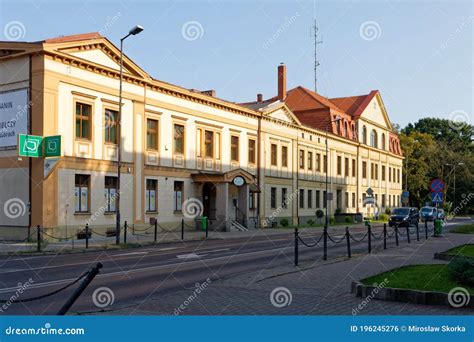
[0, 33, 403, 235]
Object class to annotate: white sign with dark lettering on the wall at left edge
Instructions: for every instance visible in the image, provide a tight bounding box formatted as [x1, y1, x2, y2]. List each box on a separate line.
[0, 89, 29, 147]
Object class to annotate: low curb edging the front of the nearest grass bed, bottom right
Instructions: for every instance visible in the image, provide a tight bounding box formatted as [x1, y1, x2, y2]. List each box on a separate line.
[351, 281, 474, 309]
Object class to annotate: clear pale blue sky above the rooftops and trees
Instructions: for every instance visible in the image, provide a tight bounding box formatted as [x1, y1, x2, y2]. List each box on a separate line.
[0, 0, 474, 126]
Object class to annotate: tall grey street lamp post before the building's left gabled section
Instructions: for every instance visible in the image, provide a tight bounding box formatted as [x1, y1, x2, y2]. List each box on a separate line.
[115, 25, 143, 245]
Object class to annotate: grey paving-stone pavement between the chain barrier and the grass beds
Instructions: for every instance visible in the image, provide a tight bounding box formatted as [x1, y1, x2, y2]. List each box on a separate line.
[101, 233, 474, 315]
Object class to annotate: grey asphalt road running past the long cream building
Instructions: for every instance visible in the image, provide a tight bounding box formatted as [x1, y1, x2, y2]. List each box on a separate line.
[0, 219, 466, 315]
